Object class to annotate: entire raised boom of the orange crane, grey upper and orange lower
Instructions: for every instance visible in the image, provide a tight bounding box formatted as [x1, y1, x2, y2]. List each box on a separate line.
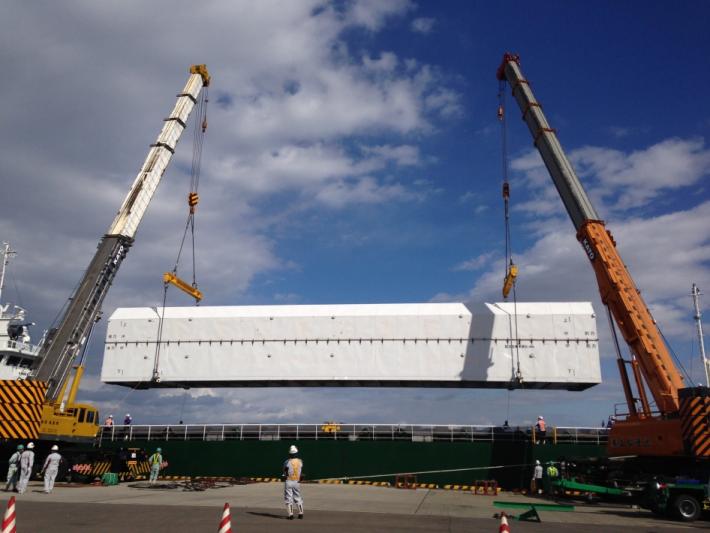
[497, 54, 683, 414]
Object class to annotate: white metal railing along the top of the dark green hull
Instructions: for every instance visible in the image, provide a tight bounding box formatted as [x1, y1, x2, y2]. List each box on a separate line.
[99, 422, 609, 445]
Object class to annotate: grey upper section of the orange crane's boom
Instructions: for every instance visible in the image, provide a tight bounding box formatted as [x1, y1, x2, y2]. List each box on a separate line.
[498, 54, 599, 230]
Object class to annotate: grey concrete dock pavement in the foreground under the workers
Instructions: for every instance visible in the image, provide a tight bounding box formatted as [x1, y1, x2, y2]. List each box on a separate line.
[2, 482, 708, 533]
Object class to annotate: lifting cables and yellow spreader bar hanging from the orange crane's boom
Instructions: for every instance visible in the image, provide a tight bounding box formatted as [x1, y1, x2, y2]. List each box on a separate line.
[498, 80, 523, 390]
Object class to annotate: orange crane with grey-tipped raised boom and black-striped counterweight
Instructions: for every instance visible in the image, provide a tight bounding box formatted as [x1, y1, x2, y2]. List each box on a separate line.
[497, 54, 710, 466]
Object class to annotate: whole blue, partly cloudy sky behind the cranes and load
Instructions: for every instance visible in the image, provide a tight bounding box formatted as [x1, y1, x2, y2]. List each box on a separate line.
[0, 0, 710, 425]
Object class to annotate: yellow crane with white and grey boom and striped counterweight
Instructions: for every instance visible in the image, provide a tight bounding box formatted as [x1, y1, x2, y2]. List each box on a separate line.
[0, 65, 210, 439]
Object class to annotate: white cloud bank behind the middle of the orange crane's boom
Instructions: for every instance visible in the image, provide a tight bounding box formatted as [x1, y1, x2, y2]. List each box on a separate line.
[468, 202, 710, 340]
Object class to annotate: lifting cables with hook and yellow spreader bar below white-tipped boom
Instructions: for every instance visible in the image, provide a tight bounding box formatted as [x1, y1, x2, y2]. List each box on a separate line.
[150, 87, 209, 386]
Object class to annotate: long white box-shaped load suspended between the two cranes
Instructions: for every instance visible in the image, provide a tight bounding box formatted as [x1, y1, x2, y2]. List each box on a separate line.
[101, 302, 601, 390]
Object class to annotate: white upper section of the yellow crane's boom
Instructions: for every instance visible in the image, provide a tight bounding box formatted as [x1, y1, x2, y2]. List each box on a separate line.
[107, 74, 203, 238]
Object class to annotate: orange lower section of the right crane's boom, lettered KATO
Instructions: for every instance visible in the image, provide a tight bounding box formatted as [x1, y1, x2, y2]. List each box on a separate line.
[577, 220, 684, 414]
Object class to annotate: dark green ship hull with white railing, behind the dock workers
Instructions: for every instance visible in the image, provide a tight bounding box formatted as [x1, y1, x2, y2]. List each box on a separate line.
[97, 423, 608, 489]
